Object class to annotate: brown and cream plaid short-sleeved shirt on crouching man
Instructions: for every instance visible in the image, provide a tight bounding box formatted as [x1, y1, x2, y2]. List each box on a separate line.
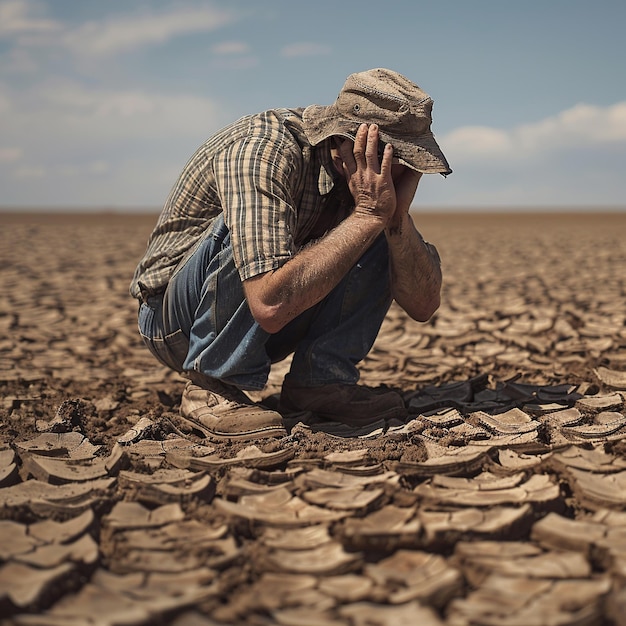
[130, 108, 352, 299]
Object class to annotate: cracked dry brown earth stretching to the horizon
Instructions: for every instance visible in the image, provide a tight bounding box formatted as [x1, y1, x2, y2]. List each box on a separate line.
[0, 214, 626, 626]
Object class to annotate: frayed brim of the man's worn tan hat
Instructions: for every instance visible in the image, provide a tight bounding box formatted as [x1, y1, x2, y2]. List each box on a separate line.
[302, 104, 452, 176]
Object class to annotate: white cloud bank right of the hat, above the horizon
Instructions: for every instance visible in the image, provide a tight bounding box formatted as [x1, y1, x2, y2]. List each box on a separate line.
[421, 102, 626, 208]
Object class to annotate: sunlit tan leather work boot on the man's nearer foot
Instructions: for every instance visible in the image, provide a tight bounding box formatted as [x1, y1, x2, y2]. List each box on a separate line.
[180, 372, 287, 441]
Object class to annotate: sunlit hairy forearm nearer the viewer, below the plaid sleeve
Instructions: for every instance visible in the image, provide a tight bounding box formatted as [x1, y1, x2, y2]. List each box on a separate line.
[244, 213, 385, 333]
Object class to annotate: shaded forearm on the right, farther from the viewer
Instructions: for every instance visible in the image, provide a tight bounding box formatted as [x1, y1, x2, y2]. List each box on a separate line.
[385, 213, 441, 322]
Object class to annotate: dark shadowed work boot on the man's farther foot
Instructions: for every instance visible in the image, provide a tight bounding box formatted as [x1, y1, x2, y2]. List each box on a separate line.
[278, 378, 407, 427]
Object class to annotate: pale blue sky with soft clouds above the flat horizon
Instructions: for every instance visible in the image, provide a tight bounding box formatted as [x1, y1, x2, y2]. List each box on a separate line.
[0, 0, 626, 211]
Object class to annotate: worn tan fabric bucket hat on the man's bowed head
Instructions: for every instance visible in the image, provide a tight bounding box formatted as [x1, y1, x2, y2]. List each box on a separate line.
[302, 68, 452, 176]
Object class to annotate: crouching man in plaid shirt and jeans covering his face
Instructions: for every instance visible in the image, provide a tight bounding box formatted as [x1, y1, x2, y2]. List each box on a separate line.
[131, 69, 451, 440]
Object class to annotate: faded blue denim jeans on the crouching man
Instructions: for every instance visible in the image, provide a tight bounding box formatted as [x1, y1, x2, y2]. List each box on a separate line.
[139, 216, 391, 390]
